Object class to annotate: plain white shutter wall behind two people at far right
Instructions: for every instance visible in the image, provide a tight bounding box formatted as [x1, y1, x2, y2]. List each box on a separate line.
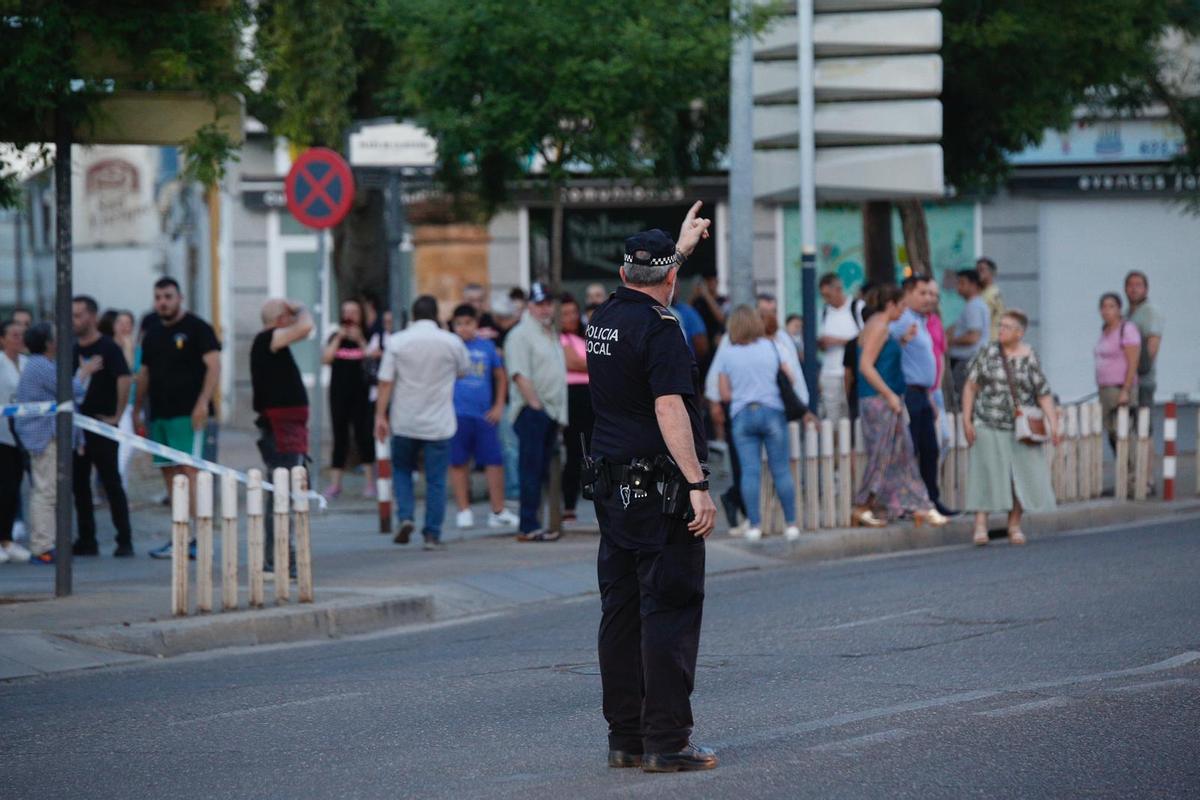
[1038, 198, 1200, 402]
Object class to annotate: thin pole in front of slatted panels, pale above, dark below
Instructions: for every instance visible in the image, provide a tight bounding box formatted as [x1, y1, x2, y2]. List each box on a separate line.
[796, 0, 817, 397]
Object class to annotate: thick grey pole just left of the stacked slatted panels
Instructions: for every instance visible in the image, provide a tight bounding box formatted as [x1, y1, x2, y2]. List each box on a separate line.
[716, 4, 753, 307]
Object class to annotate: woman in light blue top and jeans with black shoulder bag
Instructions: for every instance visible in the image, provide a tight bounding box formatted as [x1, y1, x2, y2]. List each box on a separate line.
[719, 306, 816, 541]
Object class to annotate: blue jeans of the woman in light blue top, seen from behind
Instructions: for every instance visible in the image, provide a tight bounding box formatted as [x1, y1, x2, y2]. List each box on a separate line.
[733, 403, 796, 528]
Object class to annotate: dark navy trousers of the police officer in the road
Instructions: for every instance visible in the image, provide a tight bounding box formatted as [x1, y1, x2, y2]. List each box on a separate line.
[595, 487, 704, 753]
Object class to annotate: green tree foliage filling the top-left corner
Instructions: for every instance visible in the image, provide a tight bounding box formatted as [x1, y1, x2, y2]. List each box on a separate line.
[0, 0, 250, 204]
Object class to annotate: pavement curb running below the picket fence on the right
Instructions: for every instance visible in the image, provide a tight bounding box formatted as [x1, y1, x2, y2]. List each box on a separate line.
[722, 500, 1200, 561]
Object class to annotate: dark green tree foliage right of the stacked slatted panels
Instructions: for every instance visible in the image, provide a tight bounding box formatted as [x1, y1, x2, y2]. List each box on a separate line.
[942, 0, 1180, 190]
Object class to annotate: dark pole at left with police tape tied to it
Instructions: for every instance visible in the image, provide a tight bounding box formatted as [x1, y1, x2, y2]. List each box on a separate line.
[54, 109, 74, 597]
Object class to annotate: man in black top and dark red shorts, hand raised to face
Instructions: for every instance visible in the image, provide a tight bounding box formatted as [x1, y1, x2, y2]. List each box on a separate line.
[250, 299, 312, 577]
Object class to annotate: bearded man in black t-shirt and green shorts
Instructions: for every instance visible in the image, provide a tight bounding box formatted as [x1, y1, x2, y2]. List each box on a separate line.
[133, 278, 221, 558]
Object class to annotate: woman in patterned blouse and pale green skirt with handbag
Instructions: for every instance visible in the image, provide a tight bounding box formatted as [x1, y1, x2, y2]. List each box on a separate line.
[962, 309, 1061, 546]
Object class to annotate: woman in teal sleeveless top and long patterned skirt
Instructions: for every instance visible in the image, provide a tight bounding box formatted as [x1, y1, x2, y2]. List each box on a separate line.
[852, 284, 948, 528]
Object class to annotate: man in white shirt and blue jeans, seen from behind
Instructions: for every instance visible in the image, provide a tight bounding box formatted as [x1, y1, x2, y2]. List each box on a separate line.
[376, 295, 470, 551]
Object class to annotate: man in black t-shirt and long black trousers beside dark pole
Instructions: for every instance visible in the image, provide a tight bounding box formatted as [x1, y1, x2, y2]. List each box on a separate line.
[71, 295, 133, 558]
